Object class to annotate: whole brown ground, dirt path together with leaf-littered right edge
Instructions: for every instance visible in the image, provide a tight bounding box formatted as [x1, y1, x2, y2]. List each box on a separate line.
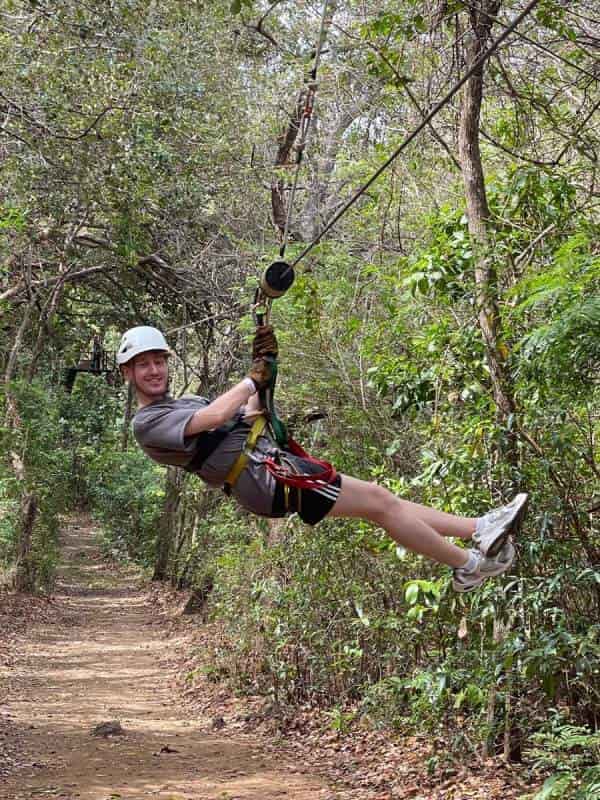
[0, 516, 540, 800]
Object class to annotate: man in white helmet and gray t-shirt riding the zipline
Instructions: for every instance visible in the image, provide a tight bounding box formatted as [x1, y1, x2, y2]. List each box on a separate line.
[117, 326, 527, 592]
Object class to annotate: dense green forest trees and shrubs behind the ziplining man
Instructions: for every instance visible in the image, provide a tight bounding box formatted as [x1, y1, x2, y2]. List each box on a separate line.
[0, 0, 600, 798]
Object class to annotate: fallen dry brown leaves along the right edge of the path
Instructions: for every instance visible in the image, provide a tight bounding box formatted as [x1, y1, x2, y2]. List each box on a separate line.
[156, 592, 533, 800]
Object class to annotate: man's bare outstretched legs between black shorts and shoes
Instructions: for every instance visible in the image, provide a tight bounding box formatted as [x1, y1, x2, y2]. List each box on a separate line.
[327, 475, 475, 568]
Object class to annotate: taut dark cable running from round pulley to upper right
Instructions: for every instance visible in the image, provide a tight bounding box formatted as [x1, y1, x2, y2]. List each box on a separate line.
[288, 0, 539, 270]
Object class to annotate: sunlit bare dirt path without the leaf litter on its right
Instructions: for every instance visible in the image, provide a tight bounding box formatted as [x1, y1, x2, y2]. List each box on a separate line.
[0, 519, 331, 800]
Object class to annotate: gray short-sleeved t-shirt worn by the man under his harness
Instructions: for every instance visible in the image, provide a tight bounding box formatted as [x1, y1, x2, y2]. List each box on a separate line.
[133, 395, 279, 517]
